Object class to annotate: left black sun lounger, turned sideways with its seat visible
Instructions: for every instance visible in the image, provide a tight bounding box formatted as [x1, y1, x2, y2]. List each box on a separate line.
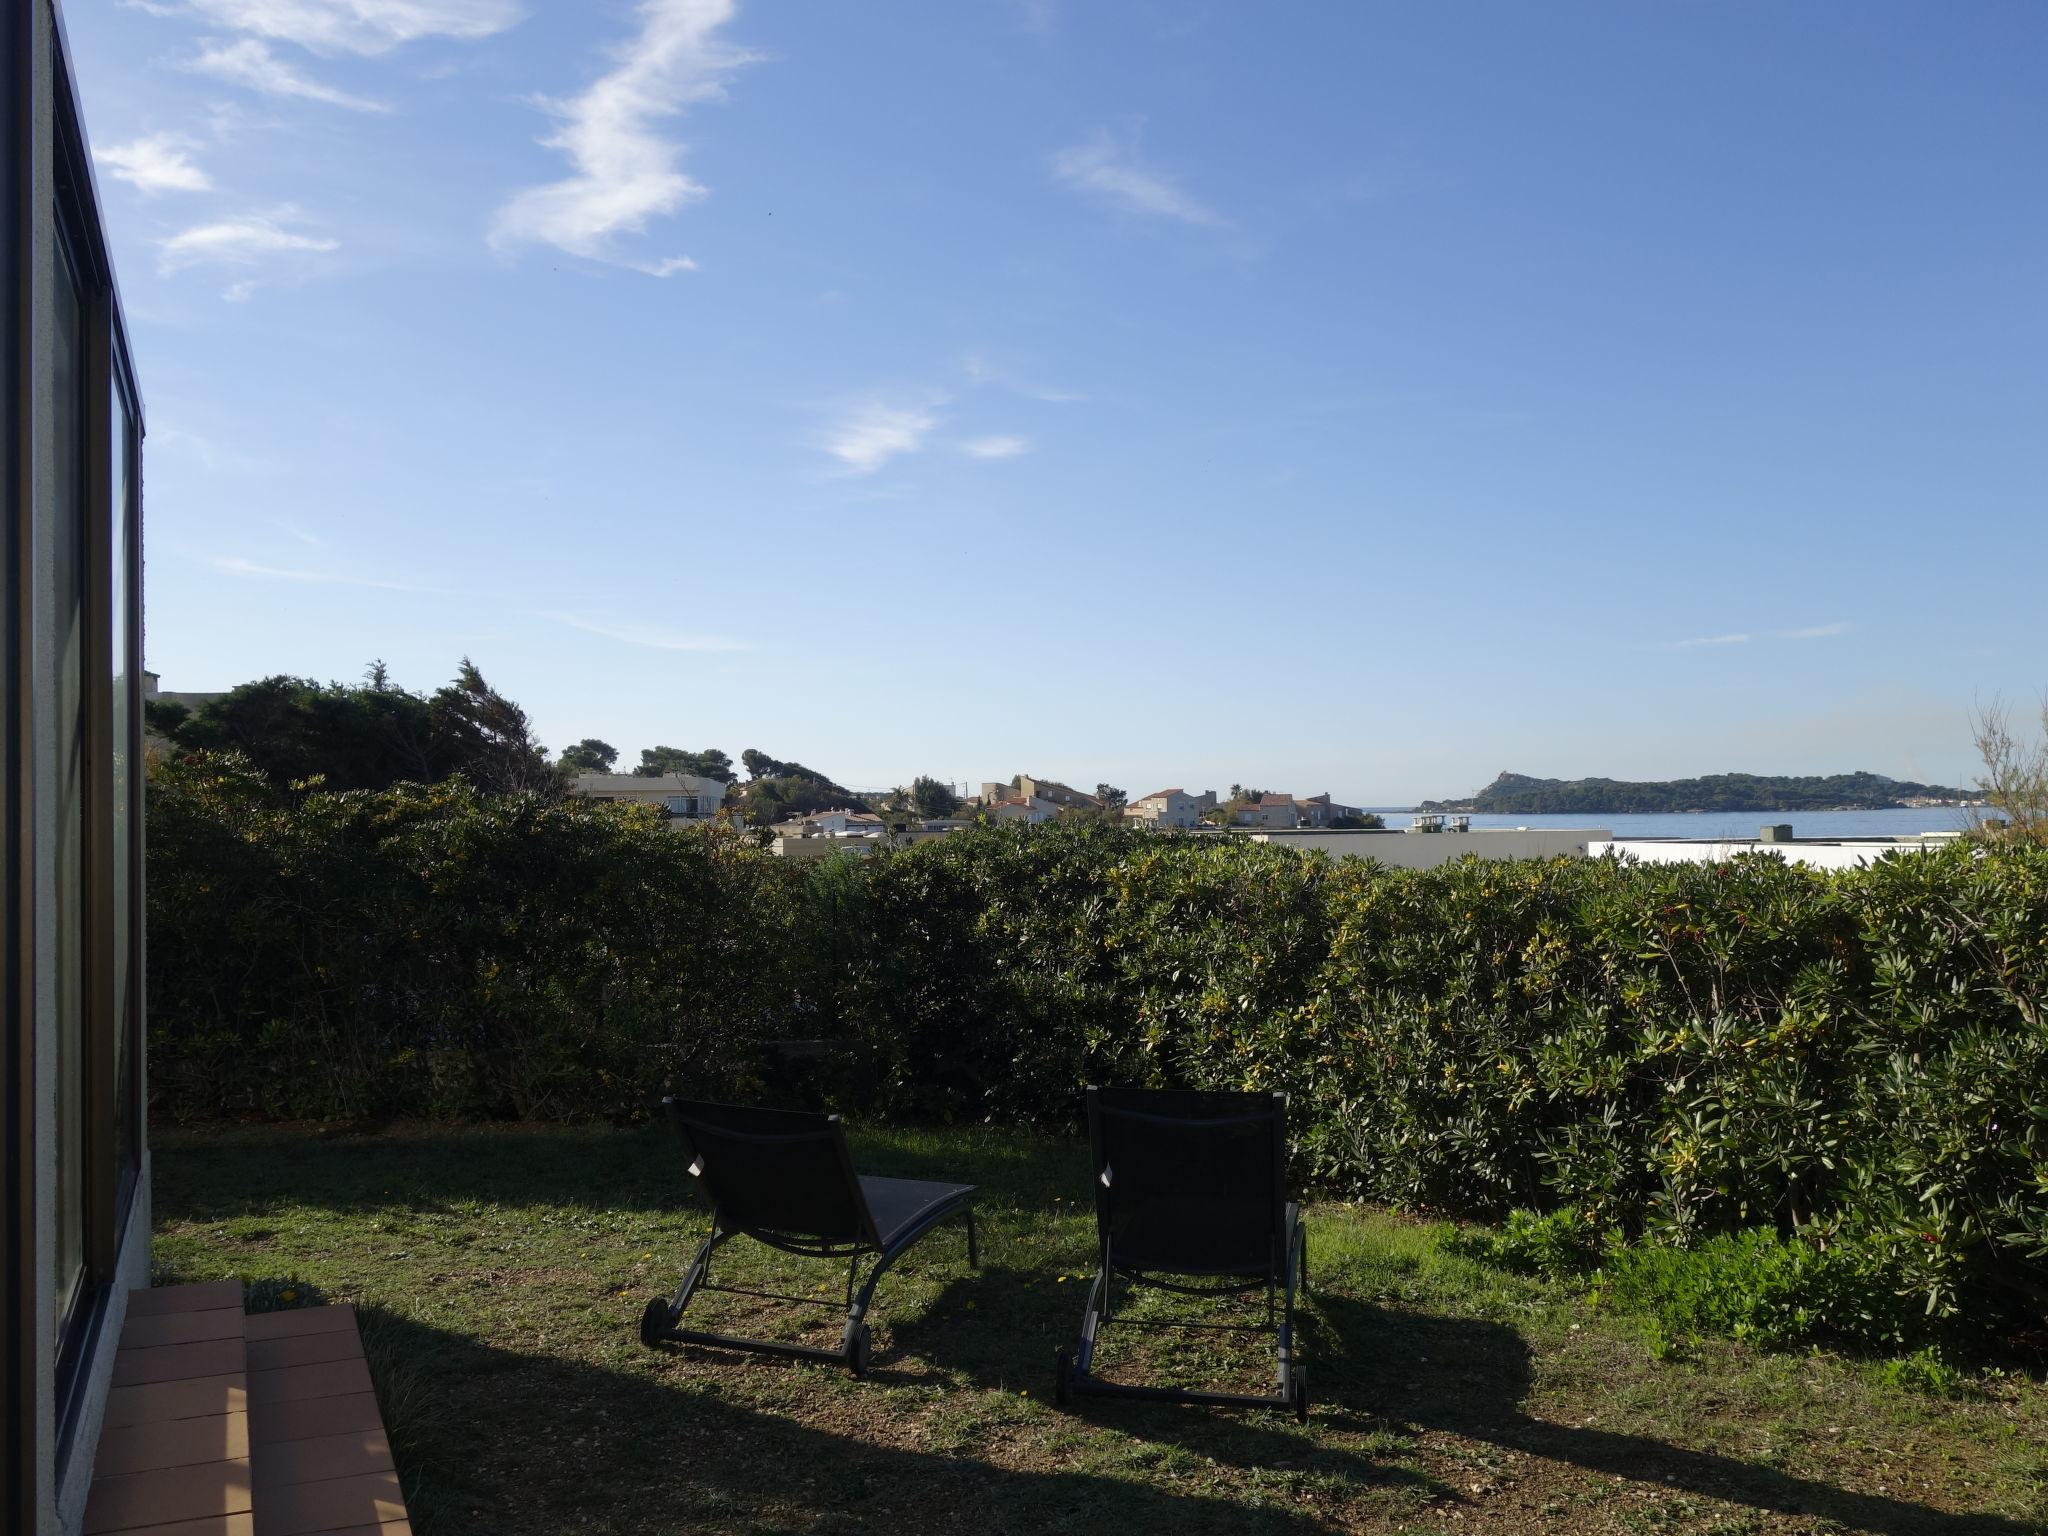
[641, 1098, 977, 1376]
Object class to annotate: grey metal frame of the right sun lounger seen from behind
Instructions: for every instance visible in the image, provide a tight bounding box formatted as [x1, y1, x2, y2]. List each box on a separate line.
[1055, 1087, 1309, 1423]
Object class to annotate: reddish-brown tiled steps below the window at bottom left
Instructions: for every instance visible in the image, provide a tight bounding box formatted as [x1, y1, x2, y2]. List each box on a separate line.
[84, 1280, 412, 1536]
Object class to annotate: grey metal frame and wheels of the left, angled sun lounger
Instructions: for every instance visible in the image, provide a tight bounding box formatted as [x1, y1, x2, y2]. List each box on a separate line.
[641, 1098, 981, 1376]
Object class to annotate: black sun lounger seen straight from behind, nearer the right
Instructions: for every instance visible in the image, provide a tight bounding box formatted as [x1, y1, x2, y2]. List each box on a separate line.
[1055, 1087, 1309, 1421]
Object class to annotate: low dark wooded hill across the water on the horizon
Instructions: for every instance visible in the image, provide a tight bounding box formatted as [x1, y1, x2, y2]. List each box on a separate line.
[1415, 774, 1976, 815]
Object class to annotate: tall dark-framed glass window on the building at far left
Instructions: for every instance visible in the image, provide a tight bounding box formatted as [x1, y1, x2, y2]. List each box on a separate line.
[44, 30, 143, 1456]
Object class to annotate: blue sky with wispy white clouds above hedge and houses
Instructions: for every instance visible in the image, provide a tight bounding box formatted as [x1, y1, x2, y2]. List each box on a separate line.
[63, 0, 2048, 805]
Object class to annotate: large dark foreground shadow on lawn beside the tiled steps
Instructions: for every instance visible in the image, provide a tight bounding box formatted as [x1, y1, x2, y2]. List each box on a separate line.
[365, 1313, 1329, 1536]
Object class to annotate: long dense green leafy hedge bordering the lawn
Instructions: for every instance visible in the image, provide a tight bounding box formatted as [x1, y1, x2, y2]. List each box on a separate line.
[150, 754, 2048, 1313]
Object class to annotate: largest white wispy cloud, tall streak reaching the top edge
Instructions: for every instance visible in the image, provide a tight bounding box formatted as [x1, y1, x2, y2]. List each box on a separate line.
[492, 0, 754, 276]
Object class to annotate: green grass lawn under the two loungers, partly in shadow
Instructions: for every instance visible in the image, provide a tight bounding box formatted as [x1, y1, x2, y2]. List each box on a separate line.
[154, 1126, 2048, 1536]
